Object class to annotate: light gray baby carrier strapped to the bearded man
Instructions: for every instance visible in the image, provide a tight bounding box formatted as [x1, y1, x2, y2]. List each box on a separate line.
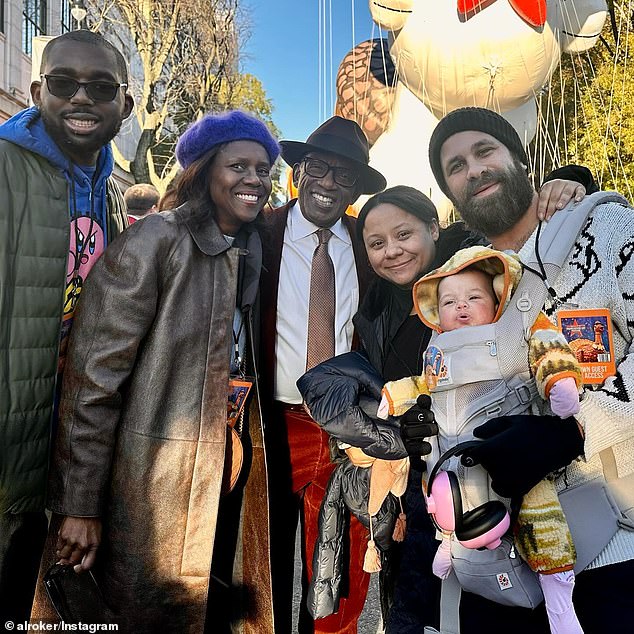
[424, 192, 631, 634]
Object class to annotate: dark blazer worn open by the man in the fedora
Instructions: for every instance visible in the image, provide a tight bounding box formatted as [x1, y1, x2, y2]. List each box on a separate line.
[260, 198, 375, 401]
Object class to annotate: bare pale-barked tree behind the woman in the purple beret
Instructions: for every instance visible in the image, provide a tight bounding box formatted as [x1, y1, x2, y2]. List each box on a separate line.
[83, 0, 275, 192]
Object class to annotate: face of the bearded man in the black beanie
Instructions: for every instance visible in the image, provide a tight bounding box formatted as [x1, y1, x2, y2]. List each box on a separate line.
[440, 130, 535, 239]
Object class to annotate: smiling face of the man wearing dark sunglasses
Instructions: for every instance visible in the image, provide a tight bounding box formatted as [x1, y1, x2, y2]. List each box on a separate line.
[31, 40, 134, 165]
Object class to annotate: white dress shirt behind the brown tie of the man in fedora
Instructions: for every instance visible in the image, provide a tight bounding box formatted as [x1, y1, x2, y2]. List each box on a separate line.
[275, 202, 359, 404]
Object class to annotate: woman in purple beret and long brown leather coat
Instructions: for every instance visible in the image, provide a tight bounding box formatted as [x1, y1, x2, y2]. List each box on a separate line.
[43, 111, 279, 634]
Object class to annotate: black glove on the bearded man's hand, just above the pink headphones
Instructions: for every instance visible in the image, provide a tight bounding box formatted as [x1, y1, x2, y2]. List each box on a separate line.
[460, 415, 583, 498]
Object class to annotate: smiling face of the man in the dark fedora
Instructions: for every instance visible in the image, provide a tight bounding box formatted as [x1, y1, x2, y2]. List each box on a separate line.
[293, 152, 360, 228]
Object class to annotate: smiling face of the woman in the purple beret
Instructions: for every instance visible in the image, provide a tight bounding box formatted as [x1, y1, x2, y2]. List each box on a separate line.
[208, 141, 272, 236]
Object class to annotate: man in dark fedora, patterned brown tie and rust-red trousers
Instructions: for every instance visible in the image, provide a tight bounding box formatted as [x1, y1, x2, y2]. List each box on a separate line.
[261, 116, 386, 634]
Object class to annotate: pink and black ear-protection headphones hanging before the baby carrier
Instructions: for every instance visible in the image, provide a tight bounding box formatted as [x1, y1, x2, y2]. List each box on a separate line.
[425, 440, 511, 549]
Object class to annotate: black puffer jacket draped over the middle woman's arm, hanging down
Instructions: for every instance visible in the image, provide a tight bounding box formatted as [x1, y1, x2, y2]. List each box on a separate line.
[297, 352, 407, 619]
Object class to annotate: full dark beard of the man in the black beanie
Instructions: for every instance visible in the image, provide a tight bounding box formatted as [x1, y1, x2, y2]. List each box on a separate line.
[453, 159, 535, 238]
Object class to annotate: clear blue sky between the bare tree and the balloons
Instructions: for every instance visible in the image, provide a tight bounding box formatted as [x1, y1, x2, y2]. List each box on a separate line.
[242, 0, 380, 141]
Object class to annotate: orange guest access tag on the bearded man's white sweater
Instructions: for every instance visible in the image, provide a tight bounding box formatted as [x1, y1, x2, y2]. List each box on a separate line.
[557, 308, 616, 385]
